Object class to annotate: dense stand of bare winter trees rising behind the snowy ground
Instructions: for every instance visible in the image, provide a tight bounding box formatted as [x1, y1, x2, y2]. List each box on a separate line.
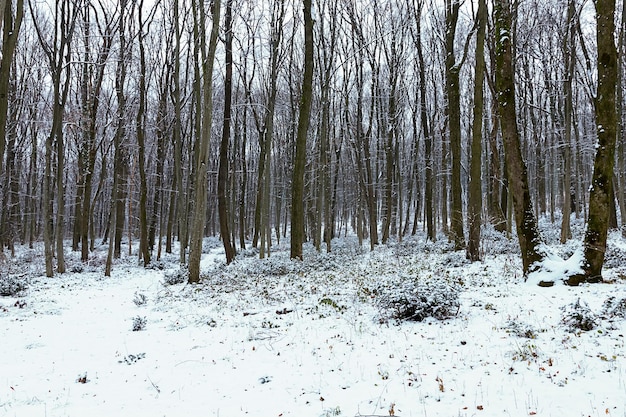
[0, 0, 626, 284]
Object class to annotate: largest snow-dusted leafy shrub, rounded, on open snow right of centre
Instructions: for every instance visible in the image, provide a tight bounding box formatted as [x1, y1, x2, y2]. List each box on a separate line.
[372, 275, 461, 321]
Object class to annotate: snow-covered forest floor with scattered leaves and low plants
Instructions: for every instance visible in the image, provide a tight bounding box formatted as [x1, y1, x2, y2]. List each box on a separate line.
[0, 218, 626, 417]
